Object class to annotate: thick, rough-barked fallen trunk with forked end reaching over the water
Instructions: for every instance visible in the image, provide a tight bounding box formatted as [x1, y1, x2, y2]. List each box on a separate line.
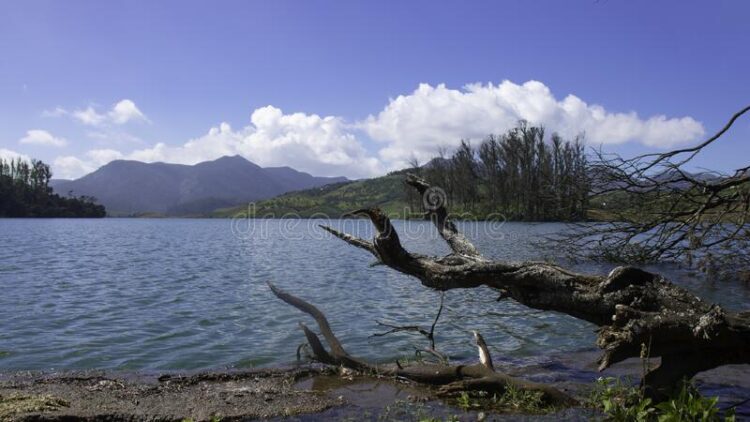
[321, 175, 750, 396]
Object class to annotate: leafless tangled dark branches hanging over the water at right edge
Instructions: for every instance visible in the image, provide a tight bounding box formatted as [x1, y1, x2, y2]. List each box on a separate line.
[558, 106, 750, 279]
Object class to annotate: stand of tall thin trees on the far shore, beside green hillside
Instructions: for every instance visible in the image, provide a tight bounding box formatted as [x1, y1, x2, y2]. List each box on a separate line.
[406, 122, 589, 221]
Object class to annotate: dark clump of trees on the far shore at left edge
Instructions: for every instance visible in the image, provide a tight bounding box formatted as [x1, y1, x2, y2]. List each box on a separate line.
[0, 158, 106, 217]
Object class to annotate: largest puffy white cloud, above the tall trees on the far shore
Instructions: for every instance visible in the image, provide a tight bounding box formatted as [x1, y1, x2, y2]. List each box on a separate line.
[360, 81, 704, 163]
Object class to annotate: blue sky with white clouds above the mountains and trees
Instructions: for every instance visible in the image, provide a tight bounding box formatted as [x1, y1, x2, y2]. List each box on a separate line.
[0, 0, 750, 177]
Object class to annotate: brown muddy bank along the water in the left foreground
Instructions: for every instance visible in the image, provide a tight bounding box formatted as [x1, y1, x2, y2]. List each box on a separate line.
[0, 368, 343, 421]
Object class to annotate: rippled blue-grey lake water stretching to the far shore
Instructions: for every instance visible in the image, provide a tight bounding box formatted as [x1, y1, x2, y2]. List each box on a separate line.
[0, 219, 750, 371]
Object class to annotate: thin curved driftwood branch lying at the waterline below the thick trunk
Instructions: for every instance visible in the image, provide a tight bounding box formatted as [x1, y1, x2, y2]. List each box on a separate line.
[268, 282, 576, 406]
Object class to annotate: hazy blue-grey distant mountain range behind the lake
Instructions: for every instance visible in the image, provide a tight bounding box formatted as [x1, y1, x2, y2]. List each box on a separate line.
[53, 156, 347, 215]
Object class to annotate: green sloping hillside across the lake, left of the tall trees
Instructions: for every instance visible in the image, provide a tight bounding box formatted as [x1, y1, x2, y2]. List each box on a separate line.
[212, 172, 406, 218]
